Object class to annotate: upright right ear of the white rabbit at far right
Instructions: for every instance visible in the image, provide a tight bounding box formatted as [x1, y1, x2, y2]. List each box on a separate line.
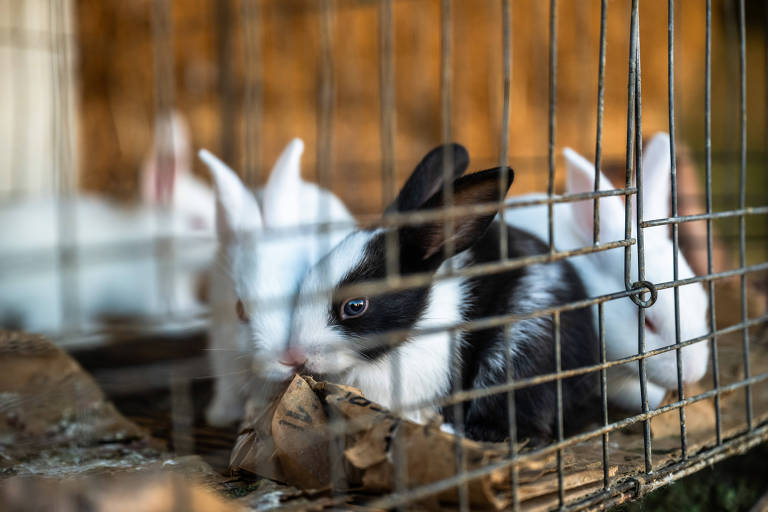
[643, 132, 672, 220]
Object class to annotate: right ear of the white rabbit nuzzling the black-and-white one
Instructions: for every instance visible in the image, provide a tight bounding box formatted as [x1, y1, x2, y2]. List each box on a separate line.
[262, 138, 307, 227]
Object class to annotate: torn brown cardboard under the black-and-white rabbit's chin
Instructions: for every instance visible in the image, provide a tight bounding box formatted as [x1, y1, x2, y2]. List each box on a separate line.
[231, 376, 616, 509]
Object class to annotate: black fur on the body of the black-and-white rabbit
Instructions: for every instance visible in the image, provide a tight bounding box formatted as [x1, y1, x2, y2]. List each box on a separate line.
[442, 222, 600, 442]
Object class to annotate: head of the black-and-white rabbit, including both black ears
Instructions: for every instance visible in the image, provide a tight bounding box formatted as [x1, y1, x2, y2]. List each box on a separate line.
[282, 145, 512, 384]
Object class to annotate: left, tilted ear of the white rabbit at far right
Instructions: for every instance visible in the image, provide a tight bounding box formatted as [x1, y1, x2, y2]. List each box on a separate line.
[563, 148, 624, 244]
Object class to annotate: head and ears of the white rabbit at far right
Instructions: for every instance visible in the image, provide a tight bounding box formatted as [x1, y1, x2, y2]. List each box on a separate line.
[564, 133, 709, 389]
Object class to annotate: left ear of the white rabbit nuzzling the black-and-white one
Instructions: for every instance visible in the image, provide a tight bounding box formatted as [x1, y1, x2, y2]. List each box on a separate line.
[198, 149, 262, 240]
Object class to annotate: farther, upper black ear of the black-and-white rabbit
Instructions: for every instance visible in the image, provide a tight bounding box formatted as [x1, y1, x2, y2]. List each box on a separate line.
[384, 143, 469, 215]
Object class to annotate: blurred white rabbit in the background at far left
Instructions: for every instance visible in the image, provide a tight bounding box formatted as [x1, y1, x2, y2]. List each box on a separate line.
[0, 112, 214, 334]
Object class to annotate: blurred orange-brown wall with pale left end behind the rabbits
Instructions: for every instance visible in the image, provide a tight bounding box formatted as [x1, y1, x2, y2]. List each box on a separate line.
[0, 0, 768, 254]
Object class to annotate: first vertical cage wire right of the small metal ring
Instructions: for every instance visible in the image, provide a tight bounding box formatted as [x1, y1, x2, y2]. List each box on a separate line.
[667, 0, 688, 459]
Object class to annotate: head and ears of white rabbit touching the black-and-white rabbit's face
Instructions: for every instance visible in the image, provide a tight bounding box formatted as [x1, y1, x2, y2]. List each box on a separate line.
[200, 139, 354, 375]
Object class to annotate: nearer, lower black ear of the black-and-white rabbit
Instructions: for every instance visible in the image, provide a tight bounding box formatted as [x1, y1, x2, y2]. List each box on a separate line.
[400, 167, 514, 268]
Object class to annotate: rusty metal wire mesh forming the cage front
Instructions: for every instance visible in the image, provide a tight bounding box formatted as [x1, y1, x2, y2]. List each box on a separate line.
[0, 0, 768, 510]
